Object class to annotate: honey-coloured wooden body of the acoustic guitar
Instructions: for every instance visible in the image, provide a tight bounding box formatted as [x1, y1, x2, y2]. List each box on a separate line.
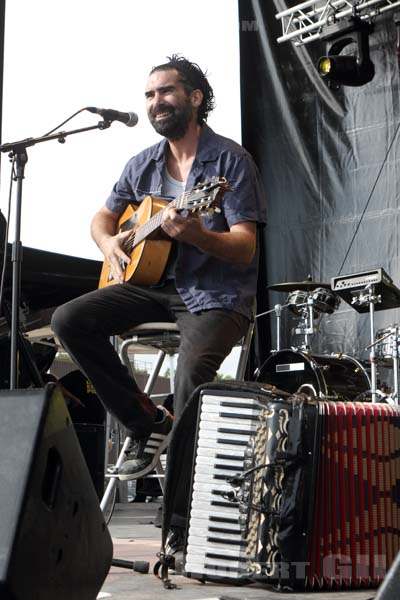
[99, 196, 172, 288]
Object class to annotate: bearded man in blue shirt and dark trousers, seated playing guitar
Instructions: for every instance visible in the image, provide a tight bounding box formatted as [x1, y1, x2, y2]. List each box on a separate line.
[52, 55, 265, 524]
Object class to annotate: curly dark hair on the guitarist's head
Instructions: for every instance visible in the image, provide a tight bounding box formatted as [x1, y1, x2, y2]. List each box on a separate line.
[150, 54, 215, 125]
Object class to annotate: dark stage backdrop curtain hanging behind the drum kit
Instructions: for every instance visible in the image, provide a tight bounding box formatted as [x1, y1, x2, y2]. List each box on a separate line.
[239, 0, 400, 384]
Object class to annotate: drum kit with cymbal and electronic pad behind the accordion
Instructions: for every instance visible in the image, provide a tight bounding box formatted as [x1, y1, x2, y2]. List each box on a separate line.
[256, 268, 400, 404]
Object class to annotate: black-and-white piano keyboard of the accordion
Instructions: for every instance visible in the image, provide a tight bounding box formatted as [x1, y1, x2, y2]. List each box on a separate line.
[185, 393, 262, 579]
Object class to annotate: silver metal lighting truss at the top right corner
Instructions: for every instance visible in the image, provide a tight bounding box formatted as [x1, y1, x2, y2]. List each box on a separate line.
[276, 0, 400, 46]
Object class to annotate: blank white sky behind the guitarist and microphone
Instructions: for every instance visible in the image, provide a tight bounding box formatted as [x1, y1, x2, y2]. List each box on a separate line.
[0, 0, 241, 374]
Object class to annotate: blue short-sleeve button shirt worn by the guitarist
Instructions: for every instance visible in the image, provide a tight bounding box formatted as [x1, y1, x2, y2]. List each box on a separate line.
[106, 124, 266, 317]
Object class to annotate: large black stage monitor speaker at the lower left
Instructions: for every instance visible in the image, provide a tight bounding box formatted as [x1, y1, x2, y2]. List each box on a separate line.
[0, 384, 112, 600]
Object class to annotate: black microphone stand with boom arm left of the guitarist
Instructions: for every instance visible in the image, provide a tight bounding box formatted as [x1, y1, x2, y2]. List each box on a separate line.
[0, 120, 112, 390]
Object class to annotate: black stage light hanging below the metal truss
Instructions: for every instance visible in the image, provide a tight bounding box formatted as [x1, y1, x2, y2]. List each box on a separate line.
[317, 16, 375, 86]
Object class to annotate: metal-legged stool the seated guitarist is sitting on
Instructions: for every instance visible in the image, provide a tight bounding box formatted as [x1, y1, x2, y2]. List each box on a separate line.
[100, 320, 254, 510]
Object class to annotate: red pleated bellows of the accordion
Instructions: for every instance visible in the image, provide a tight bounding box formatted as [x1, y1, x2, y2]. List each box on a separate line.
[307, 402, 400, 587]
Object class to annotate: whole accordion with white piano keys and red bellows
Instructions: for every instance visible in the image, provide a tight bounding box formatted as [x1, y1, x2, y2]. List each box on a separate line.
[185, 384, 400, 589]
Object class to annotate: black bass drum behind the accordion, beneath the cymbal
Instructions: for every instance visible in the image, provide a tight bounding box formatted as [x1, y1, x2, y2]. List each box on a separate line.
[257, 350, 371, 400]
